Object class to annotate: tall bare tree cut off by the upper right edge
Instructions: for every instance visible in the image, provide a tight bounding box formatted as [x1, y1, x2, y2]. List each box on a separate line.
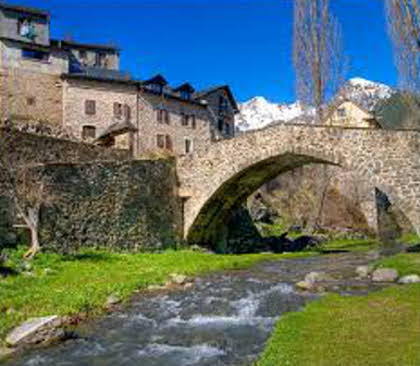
[385, 0, 420, 94]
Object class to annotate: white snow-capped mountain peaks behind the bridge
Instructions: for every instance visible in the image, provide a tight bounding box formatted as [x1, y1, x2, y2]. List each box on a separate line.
[236, 78, 394, 132]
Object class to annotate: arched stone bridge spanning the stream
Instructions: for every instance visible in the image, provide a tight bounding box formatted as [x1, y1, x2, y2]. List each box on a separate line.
[177, 124, 420, 245]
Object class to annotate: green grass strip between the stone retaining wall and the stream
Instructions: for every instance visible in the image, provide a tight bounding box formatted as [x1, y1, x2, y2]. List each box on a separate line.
[0, 248, 308, 339]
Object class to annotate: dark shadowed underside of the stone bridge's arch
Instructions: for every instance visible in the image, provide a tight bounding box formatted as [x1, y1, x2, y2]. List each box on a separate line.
[187, 153, 337, 247]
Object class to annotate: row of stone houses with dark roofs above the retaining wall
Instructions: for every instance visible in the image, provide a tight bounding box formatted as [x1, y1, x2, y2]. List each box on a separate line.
[0, 3, 238, 156]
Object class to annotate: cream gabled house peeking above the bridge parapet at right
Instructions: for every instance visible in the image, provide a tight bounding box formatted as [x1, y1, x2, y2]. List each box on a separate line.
[324, 100, 380, 128]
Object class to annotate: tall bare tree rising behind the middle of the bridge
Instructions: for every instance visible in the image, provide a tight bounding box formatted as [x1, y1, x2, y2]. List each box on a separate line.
[293, 0, 346, 121]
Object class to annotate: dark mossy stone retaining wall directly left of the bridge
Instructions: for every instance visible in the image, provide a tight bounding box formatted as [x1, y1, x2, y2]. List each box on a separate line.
[36, 160, 182, 252]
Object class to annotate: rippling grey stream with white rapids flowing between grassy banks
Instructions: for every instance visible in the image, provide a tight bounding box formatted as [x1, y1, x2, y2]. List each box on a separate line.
[6, 254, 388, 366]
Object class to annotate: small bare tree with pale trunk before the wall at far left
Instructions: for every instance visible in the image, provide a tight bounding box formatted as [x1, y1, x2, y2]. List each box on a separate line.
[0, 129, 54, 259]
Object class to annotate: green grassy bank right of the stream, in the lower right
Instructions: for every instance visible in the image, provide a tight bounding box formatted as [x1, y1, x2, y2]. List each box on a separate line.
[258, 254, 420, 366]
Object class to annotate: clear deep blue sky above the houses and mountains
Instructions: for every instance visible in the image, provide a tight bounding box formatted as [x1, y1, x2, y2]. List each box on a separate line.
[7, 0, 396, 102]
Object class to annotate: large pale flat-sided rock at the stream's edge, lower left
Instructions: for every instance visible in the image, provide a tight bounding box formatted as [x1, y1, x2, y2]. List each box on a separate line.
[6, 315, 66, 347]
